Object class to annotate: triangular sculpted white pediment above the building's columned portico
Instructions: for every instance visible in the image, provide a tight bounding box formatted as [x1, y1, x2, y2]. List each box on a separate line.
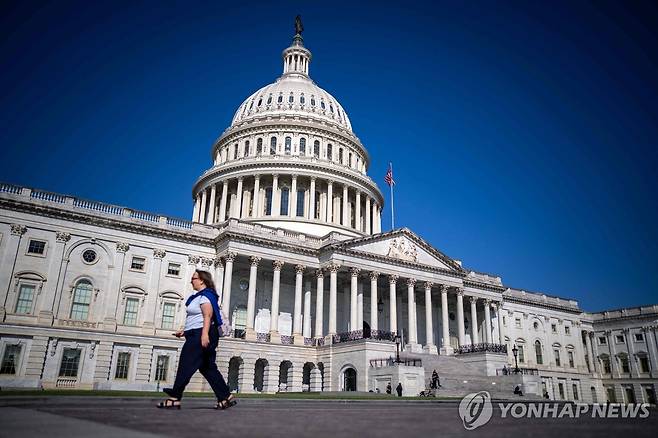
[334, 228, 463, 271]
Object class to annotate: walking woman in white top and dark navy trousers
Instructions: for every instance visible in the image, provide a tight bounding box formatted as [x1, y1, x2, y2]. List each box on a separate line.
[157, 270, 237, 409]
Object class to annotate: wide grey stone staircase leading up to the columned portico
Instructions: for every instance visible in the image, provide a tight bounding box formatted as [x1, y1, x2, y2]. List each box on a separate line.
[401, 353, 536, 400]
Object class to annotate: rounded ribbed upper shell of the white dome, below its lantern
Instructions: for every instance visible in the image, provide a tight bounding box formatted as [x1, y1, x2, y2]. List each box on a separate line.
[231, 75, 352, 132]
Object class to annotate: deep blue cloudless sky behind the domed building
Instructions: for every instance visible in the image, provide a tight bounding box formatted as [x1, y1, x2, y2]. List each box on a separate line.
[0, 1, 658, 311]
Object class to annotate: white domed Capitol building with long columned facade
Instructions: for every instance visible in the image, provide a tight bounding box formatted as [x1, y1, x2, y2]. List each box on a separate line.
[0, 20, 658, 404]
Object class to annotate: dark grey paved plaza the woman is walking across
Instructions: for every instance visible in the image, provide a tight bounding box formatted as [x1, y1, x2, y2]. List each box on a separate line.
[0, 397, 658, 438]
